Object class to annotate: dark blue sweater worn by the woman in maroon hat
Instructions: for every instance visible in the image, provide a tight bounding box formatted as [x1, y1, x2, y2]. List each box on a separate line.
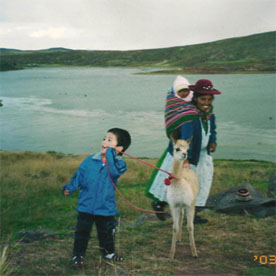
[168, 114, 217, 165]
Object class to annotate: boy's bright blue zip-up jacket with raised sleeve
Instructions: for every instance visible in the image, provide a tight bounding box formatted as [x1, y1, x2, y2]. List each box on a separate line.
[63, 148, 127, 216]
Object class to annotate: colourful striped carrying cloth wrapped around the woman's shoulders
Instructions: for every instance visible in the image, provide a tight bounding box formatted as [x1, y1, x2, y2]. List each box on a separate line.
[165, 89, 213, 138]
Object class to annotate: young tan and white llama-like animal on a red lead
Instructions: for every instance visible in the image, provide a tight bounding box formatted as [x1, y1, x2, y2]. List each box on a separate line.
[167, 139, 199, 259]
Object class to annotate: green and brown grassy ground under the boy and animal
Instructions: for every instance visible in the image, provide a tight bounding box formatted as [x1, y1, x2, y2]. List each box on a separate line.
[0, 151, 276, 276]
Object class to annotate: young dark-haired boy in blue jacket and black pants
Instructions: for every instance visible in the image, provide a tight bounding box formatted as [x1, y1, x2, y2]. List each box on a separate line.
[63, 128, 131, 267]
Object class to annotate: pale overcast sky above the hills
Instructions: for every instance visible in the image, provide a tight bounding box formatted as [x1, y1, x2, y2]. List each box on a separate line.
[0, 0, 276, 50]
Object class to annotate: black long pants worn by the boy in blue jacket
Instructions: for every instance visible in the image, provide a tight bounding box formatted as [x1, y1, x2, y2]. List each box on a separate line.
[73, 212, 117, 256]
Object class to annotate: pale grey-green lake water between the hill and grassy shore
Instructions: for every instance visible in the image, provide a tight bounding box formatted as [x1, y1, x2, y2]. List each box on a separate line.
[0, 67, 276, 162]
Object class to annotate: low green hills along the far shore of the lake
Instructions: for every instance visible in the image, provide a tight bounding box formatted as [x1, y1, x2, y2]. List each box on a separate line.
[0, 32, 276, 73]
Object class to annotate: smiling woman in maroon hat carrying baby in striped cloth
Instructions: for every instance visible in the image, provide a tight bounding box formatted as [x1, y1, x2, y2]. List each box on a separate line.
[146, 76, 221, 223]
